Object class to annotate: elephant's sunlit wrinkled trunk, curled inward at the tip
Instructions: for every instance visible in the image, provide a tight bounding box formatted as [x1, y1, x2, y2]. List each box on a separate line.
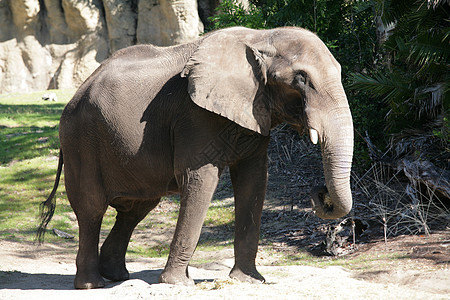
[312, 105, 353, 219]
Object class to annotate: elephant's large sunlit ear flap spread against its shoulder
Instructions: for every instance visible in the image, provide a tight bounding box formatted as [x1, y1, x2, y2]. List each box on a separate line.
[181, 32, 271, 135]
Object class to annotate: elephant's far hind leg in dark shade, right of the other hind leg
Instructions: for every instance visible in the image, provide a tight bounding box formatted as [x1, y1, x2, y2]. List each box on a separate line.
[100, 199, 160, 281]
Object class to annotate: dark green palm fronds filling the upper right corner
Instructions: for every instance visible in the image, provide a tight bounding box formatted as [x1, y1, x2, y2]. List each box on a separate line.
[352, 0, 450, 149]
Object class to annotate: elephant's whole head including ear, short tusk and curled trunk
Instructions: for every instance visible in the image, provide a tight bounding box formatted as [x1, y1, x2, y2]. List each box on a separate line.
[182, 28, 353, 219]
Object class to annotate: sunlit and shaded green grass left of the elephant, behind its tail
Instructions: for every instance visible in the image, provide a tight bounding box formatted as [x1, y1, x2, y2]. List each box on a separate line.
[0, 90, 75, 241]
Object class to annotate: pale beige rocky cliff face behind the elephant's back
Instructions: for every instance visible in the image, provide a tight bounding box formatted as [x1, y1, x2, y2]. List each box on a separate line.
[0, 0, 207, 93]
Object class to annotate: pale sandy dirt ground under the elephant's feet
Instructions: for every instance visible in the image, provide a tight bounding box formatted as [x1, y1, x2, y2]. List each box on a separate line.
[0, 233, 450, 300]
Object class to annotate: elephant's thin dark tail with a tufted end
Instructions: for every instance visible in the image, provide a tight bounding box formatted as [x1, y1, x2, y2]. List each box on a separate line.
[36, 149, 64, 243]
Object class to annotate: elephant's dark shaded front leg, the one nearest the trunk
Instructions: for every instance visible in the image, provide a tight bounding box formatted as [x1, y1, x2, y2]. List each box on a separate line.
[230, 154, 267, 283]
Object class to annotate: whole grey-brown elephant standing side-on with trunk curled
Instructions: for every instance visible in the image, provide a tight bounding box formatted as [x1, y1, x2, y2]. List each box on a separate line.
[38, 27, 353, 289]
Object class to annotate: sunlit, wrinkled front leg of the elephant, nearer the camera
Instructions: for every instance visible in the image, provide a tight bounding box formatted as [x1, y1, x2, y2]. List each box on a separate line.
[159, 164, 220, 285]
